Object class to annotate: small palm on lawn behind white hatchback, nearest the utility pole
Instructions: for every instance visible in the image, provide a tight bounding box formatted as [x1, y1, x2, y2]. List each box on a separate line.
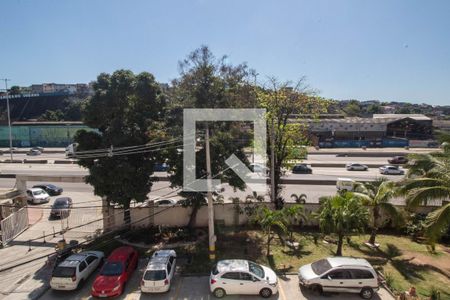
[253, 205, 287, 256]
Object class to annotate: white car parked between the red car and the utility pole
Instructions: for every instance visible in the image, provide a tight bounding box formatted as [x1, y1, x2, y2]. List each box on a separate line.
[141, 250, 177, 293]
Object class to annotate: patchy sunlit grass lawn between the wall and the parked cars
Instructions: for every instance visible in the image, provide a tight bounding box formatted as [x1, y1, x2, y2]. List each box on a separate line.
[180, 229, 450, 299]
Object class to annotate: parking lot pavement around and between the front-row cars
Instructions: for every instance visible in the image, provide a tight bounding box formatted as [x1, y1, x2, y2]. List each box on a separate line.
[40, 260, 394, 300]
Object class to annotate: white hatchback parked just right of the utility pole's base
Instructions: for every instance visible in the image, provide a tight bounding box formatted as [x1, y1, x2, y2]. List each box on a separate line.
[209, 259, 278, 298]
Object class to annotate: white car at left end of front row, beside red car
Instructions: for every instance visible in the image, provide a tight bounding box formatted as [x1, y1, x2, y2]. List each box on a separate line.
[50, 251, 105, 291]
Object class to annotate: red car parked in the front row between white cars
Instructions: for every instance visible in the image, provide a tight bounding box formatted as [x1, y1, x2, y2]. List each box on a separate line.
[91, 246, 138, 297]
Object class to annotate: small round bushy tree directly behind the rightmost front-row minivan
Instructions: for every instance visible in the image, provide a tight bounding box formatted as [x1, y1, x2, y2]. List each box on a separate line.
[318, 192, 368, 256]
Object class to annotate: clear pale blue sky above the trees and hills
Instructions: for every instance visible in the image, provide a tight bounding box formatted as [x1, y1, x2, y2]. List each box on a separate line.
[0, 0, 450, 105]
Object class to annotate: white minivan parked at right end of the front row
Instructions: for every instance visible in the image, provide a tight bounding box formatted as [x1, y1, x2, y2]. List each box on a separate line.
[298, 257, 379, 299]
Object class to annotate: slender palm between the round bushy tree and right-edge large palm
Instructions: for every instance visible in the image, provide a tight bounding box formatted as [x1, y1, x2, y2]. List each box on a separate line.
[353, 178, 401, 245]
